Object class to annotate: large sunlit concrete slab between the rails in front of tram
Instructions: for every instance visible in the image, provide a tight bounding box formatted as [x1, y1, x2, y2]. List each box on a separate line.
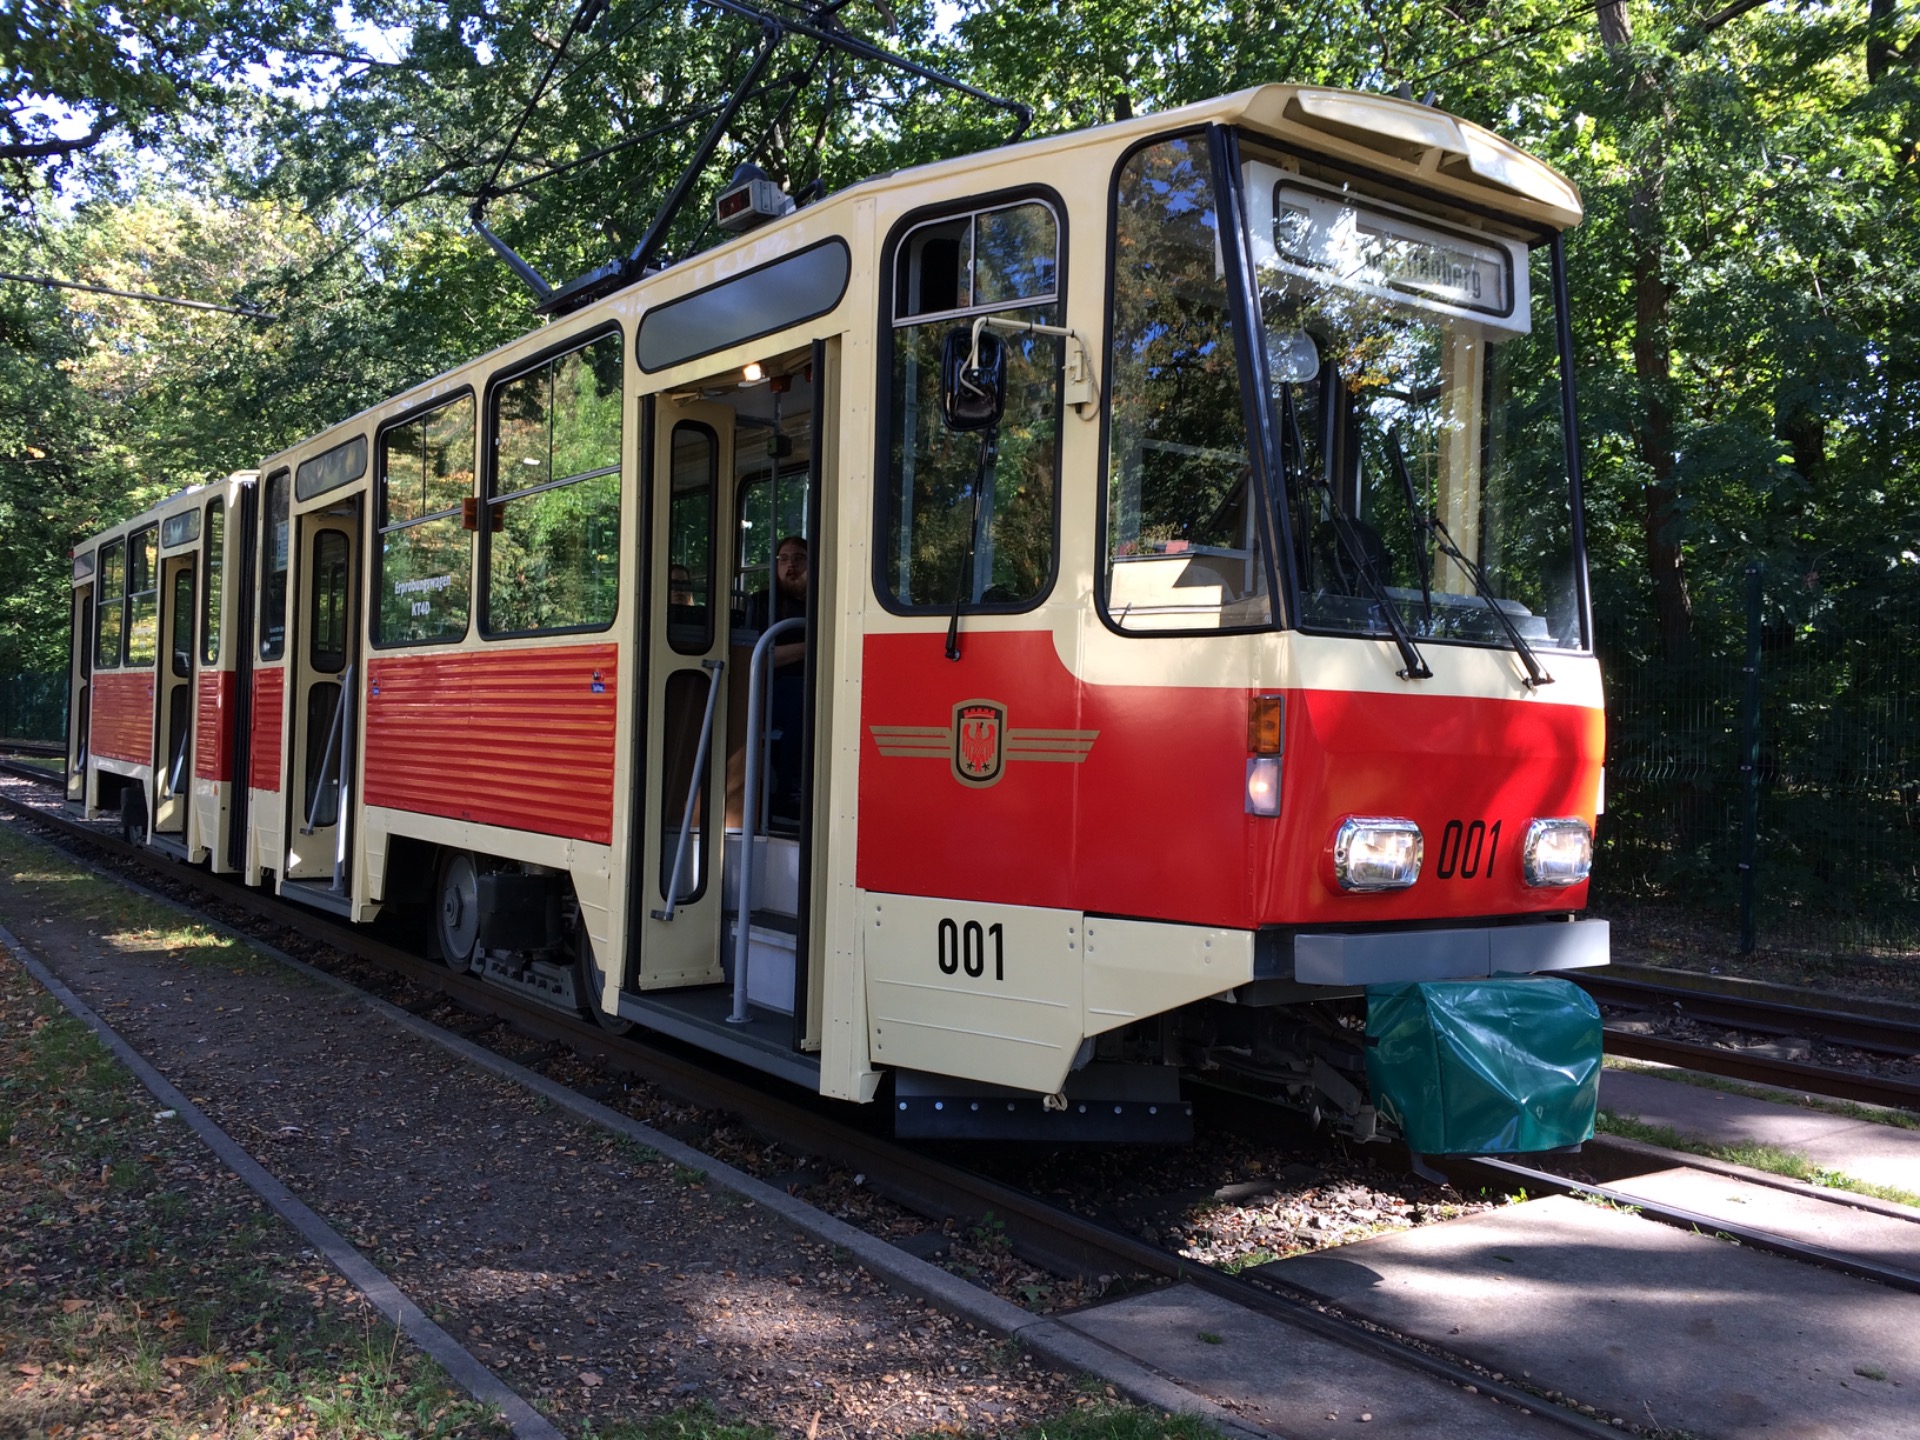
[1261, 1196, 1920, 1440]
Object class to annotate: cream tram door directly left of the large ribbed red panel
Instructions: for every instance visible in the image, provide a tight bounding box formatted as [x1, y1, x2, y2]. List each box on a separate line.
[284, 497, 361, 902]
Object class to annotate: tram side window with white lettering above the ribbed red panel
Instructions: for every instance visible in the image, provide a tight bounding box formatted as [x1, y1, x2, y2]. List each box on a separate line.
[372, 396, 474, 645]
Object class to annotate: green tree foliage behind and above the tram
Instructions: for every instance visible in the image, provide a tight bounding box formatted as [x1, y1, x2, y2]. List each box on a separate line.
[0, 0, 1920, 948]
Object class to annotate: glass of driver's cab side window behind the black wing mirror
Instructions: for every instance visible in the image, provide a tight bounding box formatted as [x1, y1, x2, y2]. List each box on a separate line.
[879, 200, 1064, 611]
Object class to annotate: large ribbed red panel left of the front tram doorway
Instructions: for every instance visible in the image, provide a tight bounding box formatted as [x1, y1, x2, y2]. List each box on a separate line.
[367, 645, 620, 845]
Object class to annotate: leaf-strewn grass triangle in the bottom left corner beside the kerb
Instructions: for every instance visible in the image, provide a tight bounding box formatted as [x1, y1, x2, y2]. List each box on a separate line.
[0, 952, 503, 1440]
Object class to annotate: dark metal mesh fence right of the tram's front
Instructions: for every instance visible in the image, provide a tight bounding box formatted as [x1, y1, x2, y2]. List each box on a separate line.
[1594, 568, 1920, 956]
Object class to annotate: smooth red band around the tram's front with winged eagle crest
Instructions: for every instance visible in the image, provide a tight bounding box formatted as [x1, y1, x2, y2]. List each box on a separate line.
[856, 630, 1603, 929]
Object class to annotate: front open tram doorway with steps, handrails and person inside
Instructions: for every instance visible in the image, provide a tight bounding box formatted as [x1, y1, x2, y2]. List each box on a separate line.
[620, 349, 820, 1089]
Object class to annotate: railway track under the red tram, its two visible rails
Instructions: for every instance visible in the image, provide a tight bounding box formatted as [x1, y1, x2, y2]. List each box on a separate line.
[0, 774, 1920, 1436]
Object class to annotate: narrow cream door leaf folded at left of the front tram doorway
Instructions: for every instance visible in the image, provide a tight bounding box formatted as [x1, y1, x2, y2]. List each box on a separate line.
[632, 399, 733, 991]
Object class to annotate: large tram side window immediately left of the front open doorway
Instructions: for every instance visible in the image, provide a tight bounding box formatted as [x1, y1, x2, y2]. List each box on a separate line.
[484, 334, 624, 636]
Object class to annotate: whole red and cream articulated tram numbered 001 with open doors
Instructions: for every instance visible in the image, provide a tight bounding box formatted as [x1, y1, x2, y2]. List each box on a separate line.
[69, 86, 1607, 1154]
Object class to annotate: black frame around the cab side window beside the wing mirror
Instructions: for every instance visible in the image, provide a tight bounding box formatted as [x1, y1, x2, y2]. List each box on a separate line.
[871, 184, 1067, 616]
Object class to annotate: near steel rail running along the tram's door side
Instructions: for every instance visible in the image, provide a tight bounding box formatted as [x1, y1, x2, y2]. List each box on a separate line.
[0, 795, 1619, 1440]
